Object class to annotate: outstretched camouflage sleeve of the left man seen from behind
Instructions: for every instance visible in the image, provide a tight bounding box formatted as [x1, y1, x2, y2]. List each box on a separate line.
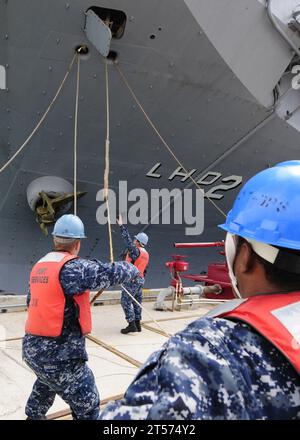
[60, 258, 139, 295]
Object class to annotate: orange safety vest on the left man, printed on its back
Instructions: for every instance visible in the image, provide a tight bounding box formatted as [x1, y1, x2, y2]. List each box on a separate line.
[25, 252, 92, 337]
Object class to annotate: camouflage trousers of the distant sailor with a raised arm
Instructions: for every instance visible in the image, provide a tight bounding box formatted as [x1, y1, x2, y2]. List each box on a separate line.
[121, 277, 145, 323]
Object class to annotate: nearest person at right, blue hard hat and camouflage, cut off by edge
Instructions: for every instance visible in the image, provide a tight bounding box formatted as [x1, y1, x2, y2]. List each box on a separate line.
[101, 161, 300, 420]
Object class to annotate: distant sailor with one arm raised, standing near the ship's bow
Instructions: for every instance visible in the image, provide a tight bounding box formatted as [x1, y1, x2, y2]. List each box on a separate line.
[117, 215, 149, 334]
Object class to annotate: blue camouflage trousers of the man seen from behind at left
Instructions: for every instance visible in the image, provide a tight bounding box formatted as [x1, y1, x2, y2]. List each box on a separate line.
[24, 359, 100, 420]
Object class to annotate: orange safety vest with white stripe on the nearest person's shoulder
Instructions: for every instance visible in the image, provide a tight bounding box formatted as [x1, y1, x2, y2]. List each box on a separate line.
[205, 292, 300, 374]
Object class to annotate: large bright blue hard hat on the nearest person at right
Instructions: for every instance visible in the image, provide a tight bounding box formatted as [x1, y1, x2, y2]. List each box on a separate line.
[220, 160, 300, 249]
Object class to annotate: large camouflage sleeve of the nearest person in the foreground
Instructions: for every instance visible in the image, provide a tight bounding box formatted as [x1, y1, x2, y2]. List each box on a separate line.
[101, 320, 247, 420]
